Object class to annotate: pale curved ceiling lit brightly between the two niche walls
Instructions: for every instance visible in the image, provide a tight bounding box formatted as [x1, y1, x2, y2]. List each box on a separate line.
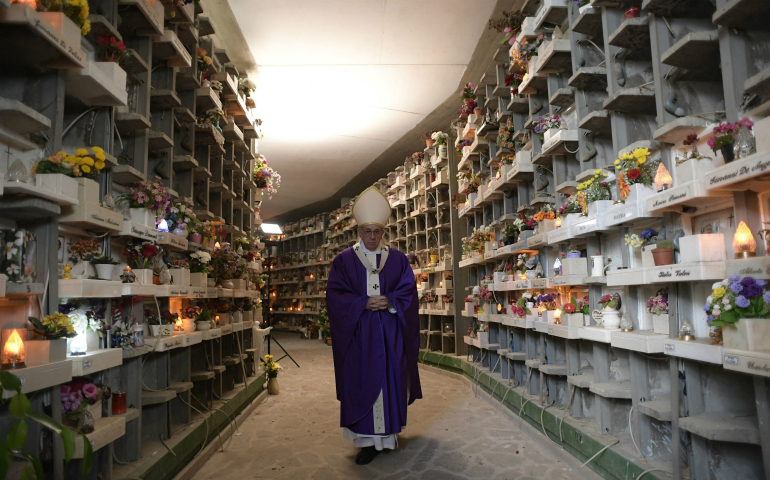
[202, 0, 515, 221]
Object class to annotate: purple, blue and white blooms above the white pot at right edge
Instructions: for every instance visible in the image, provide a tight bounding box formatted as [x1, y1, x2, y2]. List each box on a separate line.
[703, 275, 770, 327]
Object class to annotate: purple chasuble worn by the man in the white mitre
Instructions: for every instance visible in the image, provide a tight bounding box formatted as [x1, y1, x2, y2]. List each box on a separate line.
[326, 248, 422, 435]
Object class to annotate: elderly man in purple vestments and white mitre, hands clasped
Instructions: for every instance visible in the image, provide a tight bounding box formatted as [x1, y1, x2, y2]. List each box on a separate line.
[326, 187, 422, 465]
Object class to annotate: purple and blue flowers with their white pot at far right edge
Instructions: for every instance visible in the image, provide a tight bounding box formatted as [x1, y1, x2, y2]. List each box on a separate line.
[703, 275, 770, 352]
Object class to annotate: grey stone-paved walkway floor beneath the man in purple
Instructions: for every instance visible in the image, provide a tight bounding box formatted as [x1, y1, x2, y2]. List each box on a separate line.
[190, 334, 599, 480]
